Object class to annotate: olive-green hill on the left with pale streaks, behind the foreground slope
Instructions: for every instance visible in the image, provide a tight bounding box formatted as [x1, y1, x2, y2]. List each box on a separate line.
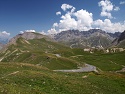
[0, 38, 77, 69]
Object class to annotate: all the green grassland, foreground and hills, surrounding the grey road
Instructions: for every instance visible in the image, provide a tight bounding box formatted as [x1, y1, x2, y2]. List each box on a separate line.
[0, 38, 125, 94]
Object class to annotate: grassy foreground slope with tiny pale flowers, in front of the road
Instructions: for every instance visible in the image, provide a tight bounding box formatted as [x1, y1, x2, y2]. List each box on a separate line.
[0, 63, 125, 94]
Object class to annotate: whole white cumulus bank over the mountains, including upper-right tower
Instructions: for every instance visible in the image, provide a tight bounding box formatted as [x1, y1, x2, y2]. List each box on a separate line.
[48, 0, 125, 34]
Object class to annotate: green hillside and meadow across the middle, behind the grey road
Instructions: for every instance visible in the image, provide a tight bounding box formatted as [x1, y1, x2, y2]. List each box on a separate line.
[0, 38, 125, 71]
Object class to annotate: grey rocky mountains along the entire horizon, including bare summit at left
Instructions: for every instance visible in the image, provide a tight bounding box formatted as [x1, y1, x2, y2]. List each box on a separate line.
[0, 29, 125, 48]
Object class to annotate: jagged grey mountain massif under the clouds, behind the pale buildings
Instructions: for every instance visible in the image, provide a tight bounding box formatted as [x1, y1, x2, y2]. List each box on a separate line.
[54, 29, 120, 48]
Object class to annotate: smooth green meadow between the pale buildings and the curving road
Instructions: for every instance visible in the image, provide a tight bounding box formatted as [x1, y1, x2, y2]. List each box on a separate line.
[69, 52, 125, 71]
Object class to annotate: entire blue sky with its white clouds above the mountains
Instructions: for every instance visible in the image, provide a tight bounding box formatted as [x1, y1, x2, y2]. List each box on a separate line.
[0, 0, 125, 37]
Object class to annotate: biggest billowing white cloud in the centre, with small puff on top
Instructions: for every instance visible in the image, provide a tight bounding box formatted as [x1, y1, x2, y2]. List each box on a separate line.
[48, 4, 93, 34]
